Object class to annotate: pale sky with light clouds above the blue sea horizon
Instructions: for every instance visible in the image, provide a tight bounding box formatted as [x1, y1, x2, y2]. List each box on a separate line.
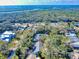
[0, 0, 79, 5]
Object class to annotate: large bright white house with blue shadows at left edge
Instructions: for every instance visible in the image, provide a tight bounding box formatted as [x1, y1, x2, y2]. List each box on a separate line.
[0, 31, 15, 42]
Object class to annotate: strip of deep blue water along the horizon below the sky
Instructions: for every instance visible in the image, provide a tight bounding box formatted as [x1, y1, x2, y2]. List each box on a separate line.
[0, 5, 79, 12]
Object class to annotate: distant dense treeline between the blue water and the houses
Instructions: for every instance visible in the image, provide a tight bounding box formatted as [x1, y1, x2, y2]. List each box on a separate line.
[0, 9, 79, 32]
